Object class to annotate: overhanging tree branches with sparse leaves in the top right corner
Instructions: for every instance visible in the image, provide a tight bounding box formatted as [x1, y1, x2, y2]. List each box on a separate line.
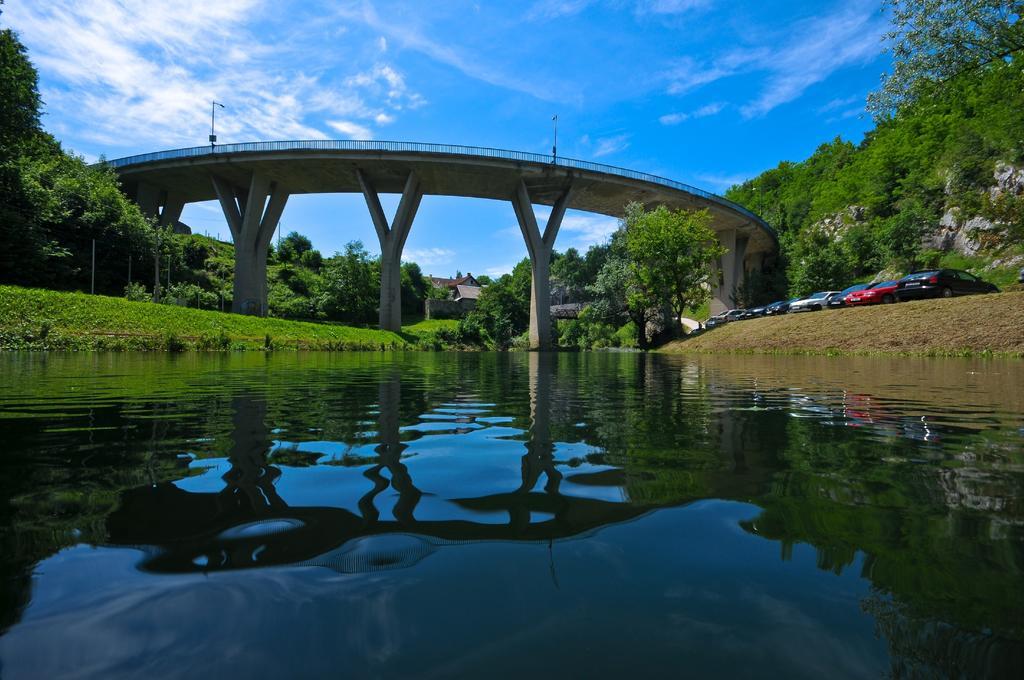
[867, 0, 1024, 118]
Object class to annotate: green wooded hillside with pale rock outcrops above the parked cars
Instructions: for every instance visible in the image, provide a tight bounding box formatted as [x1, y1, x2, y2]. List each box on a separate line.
[726, 58, 1024, 306]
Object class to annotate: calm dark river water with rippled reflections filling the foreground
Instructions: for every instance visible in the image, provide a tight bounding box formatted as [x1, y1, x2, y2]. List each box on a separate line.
[0, 353, 1024, 678]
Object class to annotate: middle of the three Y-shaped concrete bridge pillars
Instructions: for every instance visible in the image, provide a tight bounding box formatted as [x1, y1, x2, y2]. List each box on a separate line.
[355, 169, 423, 333]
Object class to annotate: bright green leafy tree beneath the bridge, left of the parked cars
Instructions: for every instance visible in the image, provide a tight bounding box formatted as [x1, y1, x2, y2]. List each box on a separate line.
[626, 204, 726, 333]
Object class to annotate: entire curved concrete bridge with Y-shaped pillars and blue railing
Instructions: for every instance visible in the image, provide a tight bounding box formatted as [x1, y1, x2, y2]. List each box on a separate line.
[110, 140, 777, 348]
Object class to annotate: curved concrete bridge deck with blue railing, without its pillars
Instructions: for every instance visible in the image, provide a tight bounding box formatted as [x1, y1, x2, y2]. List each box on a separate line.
[109, 140, 776, 252]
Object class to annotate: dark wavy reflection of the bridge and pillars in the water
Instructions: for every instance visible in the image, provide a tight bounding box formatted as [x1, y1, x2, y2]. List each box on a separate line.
[108, 353, 651, 571]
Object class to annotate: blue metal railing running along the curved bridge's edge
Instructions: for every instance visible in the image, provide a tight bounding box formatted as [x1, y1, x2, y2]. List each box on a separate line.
[106, 139, 774, 235]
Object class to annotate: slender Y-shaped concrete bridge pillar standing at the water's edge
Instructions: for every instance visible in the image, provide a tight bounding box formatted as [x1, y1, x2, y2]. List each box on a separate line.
[512, 179, 572, 349]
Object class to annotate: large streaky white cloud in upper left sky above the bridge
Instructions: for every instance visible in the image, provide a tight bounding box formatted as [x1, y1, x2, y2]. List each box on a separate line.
[4, 0, 422, 146]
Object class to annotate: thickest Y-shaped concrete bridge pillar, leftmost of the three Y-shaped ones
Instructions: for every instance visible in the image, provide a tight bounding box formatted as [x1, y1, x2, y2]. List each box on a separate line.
[212, 172, 288, 316]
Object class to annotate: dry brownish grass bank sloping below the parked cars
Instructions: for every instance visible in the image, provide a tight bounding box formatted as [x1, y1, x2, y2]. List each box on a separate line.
[663, 292, 1024, 356]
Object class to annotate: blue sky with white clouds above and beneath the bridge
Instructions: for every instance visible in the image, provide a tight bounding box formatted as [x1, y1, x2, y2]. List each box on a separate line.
[6, 0, 888, 274]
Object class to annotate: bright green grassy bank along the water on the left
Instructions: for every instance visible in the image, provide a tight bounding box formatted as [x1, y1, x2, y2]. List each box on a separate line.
[0, 286, 453, 351]
